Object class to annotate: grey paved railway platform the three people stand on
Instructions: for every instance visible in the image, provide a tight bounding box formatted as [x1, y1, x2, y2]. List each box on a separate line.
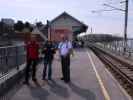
[3, 49, 132, 100]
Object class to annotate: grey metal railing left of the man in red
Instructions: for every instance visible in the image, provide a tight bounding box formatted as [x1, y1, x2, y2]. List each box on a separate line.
[0, 45, 26, 78]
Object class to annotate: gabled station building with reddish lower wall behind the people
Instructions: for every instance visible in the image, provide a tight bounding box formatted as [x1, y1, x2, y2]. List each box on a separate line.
[48, 12, 88, 42]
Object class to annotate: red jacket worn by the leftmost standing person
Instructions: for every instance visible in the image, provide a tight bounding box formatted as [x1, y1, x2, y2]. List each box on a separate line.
[26, 41, 39, 59]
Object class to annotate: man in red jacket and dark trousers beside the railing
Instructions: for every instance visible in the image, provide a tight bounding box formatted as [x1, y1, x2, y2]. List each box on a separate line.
[25, 36, 39, 84]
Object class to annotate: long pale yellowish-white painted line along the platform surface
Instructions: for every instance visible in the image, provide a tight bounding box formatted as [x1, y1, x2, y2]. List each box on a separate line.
[87, 52, 111, 100]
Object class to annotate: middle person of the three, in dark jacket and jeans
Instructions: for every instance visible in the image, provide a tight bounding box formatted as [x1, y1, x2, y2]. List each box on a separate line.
[43, 41, 55, 80]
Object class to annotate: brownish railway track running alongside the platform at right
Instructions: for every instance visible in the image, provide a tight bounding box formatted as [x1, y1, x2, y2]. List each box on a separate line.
[90, 46, 133, 97]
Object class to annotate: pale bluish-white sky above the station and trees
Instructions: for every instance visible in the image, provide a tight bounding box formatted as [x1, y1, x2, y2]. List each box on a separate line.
[0, 0, 133, 37]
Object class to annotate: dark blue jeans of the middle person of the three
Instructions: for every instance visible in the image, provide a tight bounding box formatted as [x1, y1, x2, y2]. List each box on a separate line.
[43, 59, 52, 80]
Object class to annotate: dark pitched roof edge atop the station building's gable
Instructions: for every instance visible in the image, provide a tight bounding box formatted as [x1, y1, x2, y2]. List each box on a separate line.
[50, 12, 88, 27]
